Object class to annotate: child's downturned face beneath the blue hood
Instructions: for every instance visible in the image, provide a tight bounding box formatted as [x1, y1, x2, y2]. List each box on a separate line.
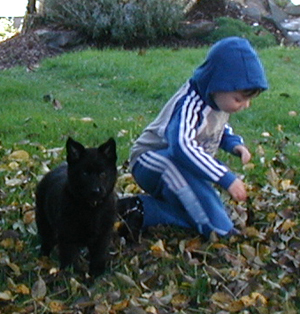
[212, 91, 253, 113]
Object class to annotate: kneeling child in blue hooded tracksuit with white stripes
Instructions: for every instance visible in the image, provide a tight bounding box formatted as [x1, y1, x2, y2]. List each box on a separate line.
[118, 37, 268, 238]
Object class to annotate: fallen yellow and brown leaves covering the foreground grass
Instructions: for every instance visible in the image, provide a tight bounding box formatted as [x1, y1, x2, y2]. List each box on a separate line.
[0, 134, 300, 314]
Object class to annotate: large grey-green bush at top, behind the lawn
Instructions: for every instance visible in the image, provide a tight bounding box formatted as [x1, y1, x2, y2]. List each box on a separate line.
[44, 0, 183, 44]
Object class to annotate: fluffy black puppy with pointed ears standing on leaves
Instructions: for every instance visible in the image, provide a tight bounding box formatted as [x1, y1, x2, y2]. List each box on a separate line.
[36, 138, 117, 276]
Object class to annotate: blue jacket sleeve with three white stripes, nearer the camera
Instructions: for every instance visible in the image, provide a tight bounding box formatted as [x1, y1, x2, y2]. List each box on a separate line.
[165, 93, 236, 189]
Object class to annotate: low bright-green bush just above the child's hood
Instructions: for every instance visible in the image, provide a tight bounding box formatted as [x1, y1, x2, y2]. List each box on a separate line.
[204, 17, 277, 48]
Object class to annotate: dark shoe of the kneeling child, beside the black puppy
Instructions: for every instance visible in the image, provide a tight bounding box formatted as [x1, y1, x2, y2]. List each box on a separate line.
[117, 196, 144, 242]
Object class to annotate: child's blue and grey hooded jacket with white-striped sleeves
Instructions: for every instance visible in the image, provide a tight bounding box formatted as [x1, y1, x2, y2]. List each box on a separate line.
[130, 37, 268, 189]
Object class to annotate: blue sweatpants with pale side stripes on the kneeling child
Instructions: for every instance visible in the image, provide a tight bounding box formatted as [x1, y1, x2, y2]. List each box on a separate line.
[132, 150, 233, 237]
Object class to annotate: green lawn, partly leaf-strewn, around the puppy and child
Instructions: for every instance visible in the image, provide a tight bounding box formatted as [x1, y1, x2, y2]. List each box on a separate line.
[0, 47, 300, 314]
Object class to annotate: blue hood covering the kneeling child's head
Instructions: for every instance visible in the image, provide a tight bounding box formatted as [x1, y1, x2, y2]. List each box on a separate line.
[191, 37, 268, 107]
